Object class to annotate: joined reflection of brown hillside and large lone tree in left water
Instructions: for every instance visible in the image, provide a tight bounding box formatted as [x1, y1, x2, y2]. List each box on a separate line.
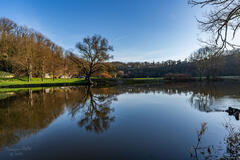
[0, 87, 117, 148]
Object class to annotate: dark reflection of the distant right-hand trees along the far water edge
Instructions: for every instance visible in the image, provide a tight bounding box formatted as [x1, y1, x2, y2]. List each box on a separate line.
[117, 82, 240, 114]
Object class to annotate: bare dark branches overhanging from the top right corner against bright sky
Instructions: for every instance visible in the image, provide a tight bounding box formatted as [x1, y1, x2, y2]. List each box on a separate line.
[188, 0, 240, 51]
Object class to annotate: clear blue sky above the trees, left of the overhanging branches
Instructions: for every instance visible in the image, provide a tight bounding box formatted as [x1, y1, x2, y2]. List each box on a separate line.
[0, 0, 206, 62]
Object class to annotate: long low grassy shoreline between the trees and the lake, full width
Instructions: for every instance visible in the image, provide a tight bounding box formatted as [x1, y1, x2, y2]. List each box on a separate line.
[0, 77, 240, 88]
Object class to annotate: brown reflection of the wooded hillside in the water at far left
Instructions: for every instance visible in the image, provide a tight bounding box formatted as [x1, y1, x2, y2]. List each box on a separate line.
[0, 89, 64, 148]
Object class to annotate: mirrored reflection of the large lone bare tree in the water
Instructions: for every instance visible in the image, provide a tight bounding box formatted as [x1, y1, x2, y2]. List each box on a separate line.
[71, 86, 116, 133]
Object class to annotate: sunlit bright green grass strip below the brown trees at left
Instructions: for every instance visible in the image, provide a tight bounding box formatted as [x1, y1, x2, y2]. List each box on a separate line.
[0, 78, 85, 86]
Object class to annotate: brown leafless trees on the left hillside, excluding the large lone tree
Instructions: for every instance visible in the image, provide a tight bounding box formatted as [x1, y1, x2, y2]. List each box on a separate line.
[0, 18, 79, 81]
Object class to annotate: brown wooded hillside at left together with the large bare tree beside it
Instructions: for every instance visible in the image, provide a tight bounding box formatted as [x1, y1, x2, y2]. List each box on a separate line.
[0, 18, 114, 81]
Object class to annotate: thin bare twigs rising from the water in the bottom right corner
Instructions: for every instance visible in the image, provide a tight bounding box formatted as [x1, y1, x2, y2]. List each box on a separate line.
[190, 121, 240, 160]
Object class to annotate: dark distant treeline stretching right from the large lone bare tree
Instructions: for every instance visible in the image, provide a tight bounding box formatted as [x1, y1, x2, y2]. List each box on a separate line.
[112, 47, 240, 78]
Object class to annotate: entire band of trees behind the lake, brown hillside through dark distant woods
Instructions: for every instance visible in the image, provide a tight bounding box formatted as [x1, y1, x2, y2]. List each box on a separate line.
[0, 17, 240, 81]
